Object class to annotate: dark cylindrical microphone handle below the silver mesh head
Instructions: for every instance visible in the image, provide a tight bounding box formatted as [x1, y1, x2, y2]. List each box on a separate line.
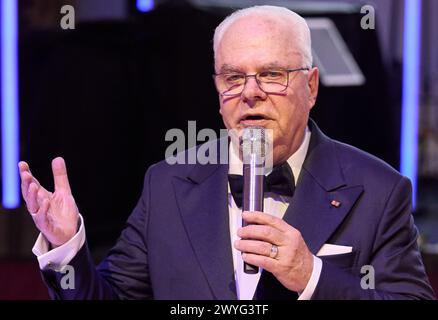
[242, 155, 265, 274]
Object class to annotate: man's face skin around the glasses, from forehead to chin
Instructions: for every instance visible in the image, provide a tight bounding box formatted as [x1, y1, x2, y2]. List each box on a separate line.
[215, 16, 318, 164]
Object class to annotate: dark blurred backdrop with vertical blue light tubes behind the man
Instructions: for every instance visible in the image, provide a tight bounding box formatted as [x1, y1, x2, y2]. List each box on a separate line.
[0, 0, 438, 299]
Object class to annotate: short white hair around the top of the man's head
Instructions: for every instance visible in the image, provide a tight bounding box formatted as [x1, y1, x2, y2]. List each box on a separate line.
[213, 6, 312, 67]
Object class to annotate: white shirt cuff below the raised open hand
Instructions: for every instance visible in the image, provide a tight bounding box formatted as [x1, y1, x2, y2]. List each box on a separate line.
[32, 215, 85, 271]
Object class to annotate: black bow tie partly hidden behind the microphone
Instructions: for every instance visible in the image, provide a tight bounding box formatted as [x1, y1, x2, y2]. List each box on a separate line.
[228, 162, 295, 208]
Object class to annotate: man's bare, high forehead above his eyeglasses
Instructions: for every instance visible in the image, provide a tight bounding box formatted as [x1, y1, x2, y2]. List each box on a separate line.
[215, 16, 302, 71]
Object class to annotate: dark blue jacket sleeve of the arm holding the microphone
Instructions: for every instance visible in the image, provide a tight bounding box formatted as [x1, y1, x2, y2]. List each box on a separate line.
[312, 177, 435, 299]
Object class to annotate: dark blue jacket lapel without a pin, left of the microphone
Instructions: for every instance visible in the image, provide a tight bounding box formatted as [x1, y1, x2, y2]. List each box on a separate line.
[173, 161, 237, 300]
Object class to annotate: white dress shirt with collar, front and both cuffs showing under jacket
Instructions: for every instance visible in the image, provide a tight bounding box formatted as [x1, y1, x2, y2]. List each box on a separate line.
[32, 128, 322, 300]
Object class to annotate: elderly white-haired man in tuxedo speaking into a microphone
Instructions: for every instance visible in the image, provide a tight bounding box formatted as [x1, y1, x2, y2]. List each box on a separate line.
[19, 6, 434, 299]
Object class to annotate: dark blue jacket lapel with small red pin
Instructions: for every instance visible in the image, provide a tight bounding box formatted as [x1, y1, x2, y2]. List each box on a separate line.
[284, 120, 363, 255]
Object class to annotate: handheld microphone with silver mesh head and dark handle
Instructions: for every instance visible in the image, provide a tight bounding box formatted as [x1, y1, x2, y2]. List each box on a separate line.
[241, 126, 265, 274]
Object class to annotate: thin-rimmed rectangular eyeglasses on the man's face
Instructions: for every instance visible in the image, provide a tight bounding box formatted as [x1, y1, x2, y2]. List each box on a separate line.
[213, 68, 309, 97]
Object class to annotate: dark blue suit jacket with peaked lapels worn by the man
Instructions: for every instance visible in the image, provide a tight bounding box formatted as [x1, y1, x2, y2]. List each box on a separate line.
[43, 121, 434, 299]
